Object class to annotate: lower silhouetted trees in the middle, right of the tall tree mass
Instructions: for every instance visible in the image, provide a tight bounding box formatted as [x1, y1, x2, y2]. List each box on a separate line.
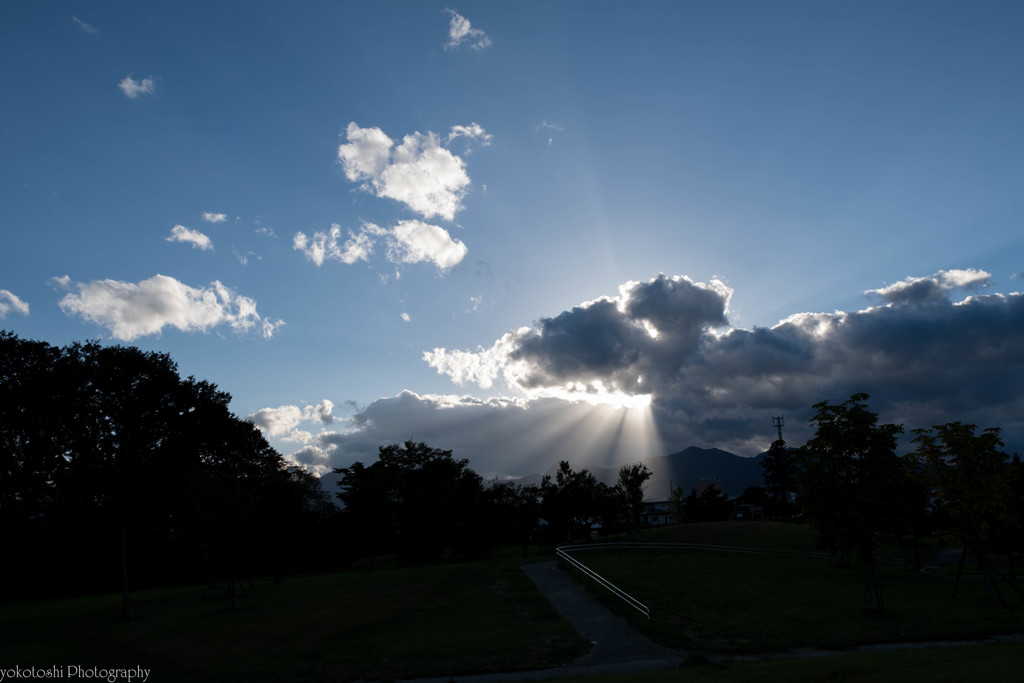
[335, 441, 651, 561]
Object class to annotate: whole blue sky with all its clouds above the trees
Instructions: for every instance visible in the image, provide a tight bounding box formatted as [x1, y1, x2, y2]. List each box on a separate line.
[0, 0, 1024, 477]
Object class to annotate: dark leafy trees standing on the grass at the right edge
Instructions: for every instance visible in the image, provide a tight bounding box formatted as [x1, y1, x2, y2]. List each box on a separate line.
[763, 393, 1024, 610]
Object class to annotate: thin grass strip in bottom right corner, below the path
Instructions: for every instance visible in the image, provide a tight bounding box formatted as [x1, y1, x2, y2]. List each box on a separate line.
[548, 643, 1024, 683]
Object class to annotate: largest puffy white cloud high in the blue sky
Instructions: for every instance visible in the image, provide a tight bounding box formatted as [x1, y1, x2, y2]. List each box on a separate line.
[338, 122, 483, 220]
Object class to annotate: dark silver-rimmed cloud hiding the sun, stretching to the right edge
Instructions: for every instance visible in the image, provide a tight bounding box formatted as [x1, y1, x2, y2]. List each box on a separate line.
[415, 269, 1024, 473]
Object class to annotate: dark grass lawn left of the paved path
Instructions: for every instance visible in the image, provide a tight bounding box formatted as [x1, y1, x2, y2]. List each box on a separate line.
[0, 561, 588, 681]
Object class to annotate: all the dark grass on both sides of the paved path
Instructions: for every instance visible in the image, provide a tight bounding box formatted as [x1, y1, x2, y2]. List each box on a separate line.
[0, 522, 1024, 683]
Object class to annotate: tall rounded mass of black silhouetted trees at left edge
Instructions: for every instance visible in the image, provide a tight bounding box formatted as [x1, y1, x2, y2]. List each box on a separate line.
[0, 332, 331, 593]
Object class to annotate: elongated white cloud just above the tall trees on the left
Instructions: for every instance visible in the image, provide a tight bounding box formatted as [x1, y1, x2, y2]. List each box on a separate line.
[60, 274, 284, 341]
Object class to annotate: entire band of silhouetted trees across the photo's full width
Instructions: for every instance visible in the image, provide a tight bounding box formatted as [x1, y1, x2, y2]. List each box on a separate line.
[0, 332, 1024, 608]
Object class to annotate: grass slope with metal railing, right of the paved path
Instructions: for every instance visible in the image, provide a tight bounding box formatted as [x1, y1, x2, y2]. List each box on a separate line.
[565, 522, 1024, 653]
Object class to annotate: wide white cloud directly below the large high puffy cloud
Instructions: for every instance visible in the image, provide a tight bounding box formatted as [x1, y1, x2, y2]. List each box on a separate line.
[292, 220, 468, 271]
